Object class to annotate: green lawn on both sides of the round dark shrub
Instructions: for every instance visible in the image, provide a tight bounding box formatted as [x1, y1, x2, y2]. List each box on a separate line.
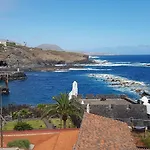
[3, 120, 46, 130]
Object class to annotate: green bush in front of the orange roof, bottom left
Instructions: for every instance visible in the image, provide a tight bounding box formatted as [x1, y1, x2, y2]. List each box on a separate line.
[7, 139, 30, 149]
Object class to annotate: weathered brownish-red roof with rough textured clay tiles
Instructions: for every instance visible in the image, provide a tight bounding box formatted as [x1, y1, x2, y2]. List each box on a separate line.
[75, 113, 137, 150]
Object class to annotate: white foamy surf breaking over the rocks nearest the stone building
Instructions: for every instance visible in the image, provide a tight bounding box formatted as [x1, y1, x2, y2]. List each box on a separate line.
[88, 74, 149, 94]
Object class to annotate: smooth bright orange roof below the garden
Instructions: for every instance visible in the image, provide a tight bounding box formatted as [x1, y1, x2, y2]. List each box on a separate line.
[4, 129, 79, 150]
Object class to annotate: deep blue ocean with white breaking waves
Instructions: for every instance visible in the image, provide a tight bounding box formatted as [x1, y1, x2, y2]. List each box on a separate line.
[3, 55, 150, 105]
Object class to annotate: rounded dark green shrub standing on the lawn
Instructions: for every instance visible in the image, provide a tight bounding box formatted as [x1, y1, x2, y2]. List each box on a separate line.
[14, 122, 33, 131]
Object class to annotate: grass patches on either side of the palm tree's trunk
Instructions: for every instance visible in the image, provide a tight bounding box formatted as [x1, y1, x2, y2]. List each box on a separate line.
[50, 118, 76, 128]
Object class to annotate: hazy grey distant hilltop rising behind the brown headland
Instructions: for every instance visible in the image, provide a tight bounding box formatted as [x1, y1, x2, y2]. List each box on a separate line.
[37, 44, 63, 51]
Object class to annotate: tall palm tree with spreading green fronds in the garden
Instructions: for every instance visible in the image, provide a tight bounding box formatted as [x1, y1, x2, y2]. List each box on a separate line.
[43, 93, 84, 128]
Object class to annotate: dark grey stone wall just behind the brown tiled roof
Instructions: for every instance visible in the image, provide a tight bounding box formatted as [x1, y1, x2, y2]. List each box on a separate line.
[89, 104, 148, 120]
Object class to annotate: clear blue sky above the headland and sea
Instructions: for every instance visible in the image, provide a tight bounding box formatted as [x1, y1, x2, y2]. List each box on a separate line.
[0, 0, 150, 54]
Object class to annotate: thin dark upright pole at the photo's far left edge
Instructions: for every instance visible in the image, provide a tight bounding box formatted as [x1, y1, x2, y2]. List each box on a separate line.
[0, 87, 3, 148]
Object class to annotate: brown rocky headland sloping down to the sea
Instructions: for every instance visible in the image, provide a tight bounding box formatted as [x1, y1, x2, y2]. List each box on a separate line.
[0, 46, 88, 68]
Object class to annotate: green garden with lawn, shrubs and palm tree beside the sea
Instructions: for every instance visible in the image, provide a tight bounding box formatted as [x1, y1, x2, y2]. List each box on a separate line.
[3, 93, 84, 131]
